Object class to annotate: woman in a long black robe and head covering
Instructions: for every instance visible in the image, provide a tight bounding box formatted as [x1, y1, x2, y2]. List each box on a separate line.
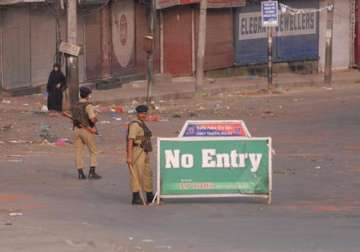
[46, 64, 66, 112]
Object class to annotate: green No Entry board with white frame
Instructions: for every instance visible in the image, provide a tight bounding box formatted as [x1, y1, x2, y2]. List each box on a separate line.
[157, 137, 272, 203]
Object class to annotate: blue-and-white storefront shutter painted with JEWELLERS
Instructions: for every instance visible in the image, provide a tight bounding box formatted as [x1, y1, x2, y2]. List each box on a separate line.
[235, 0, 319, 65]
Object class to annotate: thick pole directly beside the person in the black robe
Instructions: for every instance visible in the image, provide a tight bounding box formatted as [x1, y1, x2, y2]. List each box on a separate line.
[66, 0, 79, 106]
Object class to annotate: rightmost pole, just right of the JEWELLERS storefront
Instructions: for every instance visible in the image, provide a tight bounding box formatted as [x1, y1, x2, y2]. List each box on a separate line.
[324, 0, 334, 86]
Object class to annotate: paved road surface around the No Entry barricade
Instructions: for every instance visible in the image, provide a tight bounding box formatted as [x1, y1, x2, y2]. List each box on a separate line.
[0, 86, 360, 252]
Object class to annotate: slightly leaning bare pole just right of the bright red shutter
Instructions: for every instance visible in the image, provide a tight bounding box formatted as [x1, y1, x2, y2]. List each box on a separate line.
[195, 0, 208, 91]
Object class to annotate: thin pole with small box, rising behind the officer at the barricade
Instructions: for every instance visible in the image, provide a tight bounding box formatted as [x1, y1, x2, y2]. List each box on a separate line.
[145, 0, 156, 104]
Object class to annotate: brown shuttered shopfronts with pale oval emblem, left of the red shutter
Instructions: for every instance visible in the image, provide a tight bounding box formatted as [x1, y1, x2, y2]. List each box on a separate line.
[0, 0, 150, 90]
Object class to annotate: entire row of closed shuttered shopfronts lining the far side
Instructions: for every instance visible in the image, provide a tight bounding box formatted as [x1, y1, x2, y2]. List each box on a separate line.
[0, 0, 354, 90]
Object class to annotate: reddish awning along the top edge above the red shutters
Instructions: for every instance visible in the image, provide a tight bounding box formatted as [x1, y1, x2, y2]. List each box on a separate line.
[156, 0, 246, 9]
